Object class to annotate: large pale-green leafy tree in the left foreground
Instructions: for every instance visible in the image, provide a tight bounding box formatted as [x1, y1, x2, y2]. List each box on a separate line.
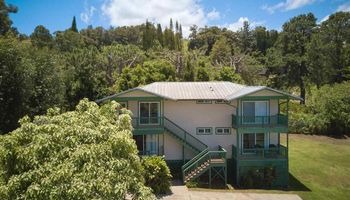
[0, 99, 154, 199]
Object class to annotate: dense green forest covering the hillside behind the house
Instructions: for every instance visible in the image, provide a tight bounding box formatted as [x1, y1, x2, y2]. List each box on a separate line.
[0, 0, 350, 134]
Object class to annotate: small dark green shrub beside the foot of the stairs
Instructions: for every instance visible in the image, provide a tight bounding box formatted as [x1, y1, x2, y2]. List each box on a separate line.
[142, 156, 172, 194]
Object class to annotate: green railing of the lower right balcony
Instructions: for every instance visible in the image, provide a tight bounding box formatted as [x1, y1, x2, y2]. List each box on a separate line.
[232, 145, 288, 159]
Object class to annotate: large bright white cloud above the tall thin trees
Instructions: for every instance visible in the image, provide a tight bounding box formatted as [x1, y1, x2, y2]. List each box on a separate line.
[102, 0, 207, 36]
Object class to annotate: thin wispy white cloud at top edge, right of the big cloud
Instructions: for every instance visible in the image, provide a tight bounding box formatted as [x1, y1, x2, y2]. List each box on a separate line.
[262, 0, 316, 14]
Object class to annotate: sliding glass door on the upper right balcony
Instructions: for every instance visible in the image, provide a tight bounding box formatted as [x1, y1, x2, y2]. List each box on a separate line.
[242, 101, 269, 124]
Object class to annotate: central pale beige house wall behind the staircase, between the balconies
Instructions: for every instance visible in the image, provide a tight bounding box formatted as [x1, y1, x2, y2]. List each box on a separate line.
[164, 100, 236, 159]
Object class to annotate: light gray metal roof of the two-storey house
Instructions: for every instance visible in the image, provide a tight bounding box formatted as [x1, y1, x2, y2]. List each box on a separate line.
[97, 81, 302, 102]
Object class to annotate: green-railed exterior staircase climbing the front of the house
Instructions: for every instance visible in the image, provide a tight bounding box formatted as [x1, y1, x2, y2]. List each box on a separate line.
[163, 117, 227, 185]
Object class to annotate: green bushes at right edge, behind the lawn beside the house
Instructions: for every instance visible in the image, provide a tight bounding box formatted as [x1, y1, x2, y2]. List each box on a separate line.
[289, 82, 350, 135]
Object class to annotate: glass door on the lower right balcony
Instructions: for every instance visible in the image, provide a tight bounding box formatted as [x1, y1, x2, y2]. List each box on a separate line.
[242, 133, 265, 153]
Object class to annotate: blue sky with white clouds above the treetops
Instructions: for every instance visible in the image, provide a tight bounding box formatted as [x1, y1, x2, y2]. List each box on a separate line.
[5, 0, 350, 35]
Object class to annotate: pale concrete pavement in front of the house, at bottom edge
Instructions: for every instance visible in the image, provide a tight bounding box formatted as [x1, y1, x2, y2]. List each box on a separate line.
[159, 185, 301, 200]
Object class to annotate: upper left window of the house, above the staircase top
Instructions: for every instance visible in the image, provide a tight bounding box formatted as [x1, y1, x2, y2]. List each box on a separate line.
[139, 102, 160, 125]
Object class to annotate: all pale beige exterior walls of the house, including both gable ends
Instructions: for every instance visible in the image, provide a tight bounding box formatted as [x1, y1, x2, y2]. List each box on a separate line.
[120, 90, 280, 160]
